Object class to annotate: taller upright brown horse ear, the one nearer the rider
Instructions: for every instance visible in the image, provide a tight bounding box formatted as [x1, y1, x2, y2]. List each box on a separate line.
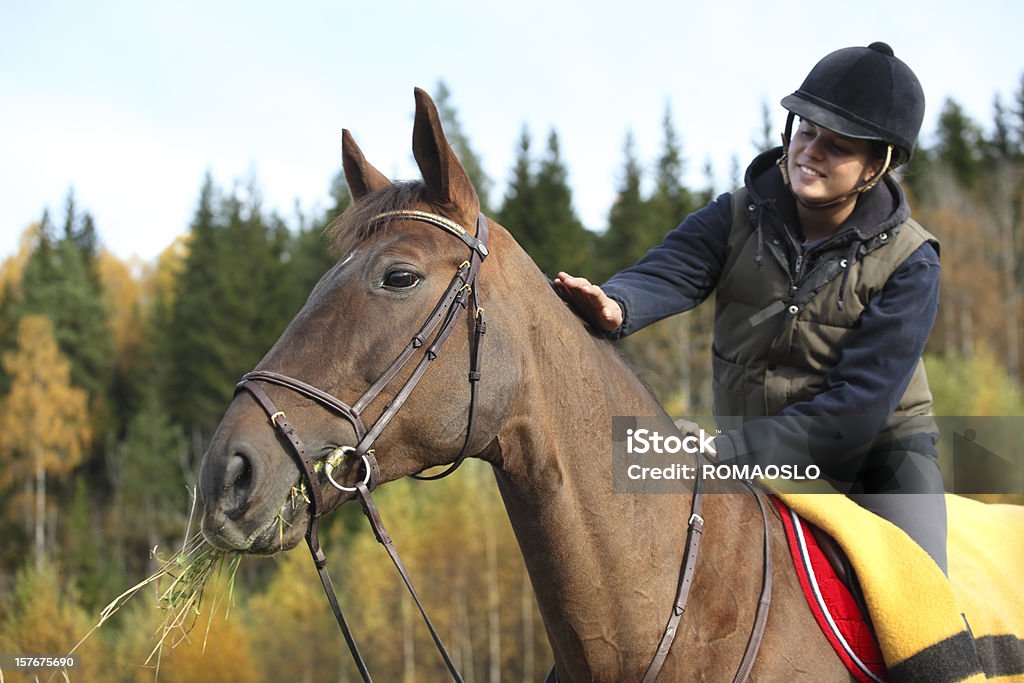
[413, 88, 480, 222]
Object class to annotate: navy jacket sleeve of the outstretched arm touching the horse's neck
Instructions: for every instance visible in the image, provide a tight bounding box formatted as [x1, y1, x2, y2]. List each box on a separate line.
[601, 194, 732, 339]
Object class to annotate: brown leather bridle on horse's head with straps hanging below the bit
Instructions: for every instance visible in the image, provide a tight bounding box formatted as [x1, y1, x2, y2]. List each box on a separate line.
[234, 209, 487, 682]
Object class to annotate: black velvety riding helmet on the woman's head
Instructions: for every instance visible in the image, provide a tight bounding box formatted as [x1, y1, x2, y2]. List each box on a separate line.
[781, 43, 925, 167]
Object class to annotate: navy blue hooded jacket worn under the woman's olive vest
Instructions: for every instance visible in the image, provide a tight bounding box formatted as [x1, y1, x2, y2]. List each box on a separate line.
[602, 150, 940, 464]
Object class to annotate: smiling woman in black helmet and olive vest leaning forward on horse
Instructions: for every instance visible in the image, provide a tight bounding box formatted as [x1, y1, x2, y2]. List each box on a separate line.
[554, 43, 946, 571]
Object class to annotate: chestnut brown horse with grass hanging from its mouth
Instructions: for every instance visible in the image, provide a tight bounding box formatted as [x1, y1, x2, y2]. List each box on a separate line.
[195, 90, 850, 682]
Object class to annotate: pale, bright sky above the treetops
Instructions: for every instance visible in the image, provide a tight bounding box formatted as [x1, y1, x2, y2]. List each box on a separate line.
[0, 0, 1024, 260]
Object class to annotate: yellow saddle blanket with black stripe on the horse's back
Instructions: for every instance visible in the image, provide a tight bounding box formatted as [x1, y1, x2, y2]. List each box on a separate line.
[777, 493, 1024, 683]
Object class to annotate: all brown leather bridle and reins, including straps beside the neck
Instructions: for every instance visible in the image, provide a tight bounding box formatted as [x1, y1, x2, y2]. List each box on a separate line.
[234, 210, 771, 683]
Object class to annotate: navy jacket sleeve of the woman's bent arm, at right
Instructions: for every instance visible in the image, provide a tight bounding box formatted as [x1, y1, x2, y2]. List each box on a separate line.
[715, 243, 940, 473]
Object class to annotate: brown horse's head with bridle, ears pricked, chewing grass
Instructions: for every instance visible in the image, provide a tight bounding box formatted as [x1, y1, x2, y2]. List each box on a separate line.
[200, 89, 528, 554]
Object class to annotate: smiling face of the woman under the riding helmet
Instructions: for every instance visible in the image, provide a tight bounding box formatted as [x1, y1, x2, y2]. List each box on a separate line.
[786, 120, 881, 204]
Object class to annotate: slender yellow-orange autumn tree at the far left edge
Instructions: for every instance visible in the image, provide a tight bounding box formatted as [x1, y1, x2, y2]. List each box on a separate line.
[0, 315, 91, 568]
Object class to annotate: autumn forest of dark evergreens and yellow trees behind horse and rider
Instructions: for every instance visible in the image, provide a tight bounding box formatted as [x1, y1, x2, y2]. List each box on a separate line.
[6, 78, 1024, 683]
